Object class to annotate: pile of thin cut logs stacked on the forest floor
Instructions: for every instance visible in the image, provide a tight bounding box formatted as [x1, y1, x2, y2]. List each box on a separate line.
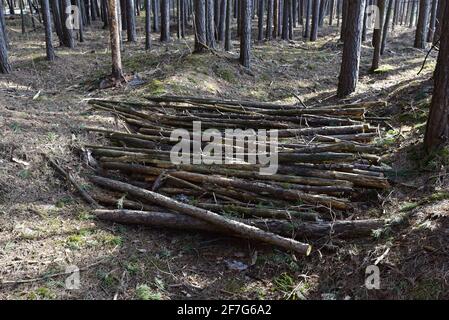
[86, 96, 389, 255]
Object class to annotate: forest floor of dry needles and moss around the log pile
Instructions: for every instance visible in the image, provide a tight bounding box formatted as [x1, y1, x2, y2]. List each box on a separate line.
[0, 16, 449, 299]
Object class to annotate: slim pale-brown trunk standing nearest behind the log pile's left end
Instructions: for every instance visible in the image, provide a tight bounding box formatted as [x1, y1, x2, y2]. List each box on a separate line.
[108, 0, 123, 79]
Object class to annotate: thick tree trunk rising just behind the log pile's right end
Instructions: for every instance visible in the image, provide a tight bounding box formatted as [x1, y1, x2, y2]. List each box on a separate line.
[337, 0, 366, 98]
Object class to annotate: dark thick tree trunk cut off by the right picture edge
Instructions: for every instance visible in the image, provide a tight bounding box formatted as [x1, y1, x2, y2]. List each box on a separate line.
[424, 1, 449, 152]
